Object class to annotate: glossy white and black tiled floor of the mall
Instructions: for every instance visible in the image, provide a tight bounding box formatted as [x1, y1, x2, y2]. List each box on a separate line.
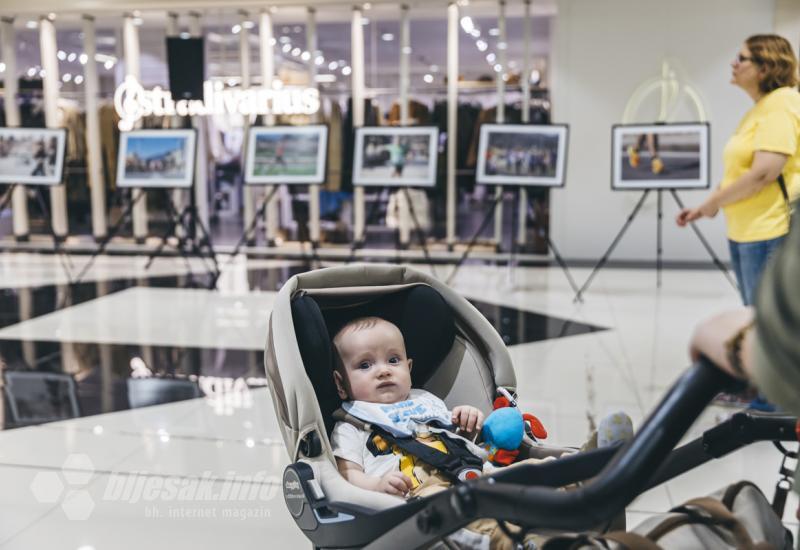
[0, 254, 797, 550]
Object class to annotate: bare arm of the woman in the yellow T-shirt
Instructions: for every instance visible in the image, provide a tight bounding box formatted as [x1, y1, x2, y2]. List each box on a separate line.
[675, 151, 789, 227]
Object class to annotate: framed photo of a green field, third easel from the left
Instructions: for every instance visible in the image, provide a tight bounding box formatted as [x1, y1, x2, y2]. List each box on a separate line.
[244, 125, 328, 185]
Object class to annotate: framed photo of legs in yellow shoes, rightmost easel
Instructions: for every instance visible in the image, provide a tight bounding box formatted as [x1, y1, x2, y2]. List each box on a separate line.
[611, 122, 711, 189]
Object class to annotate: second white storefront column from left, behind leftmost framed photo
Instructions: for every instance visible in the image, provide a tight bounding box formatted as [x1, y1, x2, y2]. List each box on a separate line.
[39, 17, 69, 239]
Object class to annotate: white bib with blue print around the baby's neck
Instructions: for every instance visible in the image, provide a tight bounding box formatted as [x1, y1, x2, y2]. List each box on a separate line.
[342, 389, 453, 437]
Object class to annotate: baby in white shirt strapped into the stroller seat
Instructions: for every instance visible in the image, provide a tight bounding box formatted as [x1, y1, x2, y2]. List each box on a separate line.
[331, 317, 483, 496]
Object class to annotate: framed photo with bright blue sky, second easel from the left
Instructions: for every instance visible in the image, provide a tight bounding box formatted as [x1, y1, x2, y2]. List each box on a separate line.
[117, 129, 197, 188]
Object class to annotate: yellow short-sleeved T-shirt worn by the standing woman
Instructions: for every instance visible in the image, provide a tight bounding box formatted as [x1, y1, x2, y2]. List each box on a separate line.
[720, 87, 800, 243]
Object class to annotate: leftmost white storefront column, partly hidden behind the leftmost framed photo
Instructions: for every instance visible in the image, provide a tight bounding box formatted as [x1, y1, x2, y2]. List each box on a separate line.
[0, 17, 30, 240]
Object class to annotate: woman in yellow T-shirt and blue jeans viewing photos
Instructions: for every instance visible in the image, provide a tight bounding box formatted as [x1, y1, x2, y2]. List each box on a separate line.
[676, 35, 800, 305]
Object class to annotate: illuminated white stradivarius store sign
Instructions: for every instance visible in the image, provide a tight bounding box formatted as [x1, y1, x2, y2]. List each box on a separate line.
[114, 76, 320, 132]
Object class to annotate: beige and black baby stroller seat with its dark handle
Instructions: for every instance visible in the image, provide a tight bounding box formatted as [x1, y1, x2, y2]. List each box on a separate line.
[265, 264, 798, 548]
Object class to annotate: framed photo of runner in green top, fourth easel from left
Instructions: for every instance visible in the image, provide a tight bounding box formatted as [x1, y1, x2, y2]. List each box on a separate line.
[353, 126, 439, 187]
